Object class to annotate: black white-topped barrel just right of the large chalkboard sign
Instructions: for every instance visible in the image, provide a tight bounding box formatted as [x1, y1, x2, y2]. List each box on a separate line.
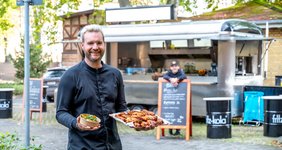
[204, 97, 234, 139]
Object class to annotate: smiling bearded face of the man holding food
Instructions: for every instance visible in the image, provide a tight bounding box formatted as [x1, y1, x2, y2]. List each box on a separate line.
[82, 32, 105, 62]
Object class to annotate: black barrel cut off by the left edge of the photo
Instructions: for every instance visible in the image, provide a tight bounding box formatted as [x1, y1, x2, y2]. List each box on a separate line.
[0, 88, 14, 118]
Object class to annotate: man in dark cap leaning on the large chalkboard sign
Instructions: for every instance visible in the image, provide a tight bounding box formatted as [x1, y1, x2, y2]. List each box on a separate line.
[163, 60, 187, 135]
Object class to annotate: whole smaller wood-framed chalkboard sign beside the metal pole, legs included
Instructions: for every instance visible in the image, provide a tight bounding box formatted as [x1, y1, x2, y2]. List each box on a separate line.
[22, 78, 43, 123]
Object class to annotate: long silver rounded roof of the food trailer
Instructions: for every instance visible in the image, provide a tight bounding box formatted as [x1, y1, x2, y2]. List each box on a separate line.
[103, 19, 268, 42]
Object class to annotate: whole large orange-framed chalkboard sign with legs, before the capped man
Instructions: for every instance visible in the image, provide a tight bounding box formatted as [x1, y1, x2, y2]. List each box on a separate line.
[156, 78, 192, 140]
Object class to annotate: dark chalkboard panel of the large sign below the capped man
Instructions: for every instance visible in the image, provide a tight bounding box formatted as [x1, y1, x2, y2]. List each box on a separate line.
[161, 79, 187, 125]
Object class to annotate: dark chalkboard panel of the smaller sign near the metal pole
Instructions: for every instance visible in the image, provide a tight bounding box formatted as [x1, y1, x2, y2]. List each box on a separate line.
[29, 79, 43, 110]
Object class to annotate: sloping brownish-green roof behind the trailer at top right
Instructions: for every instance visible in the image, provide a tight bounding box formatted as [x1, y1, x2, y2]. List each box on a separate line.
[188, 1, 282, 21]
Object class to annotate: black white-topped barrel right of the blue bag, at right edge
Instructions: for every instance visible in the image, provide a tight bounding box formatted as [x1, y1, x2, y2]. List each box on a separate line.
[263, 95, 282, 137]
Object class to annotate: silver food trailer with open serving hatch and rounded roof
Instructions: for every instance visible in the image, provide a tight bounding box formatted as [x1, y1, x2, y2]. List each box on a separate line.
[100, 19, 268, 116]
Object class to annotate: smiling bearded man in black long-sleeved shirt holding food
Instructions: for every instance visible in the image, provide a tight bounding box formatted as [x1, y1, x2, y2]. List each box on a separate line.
[56, 25, 127, 150]
